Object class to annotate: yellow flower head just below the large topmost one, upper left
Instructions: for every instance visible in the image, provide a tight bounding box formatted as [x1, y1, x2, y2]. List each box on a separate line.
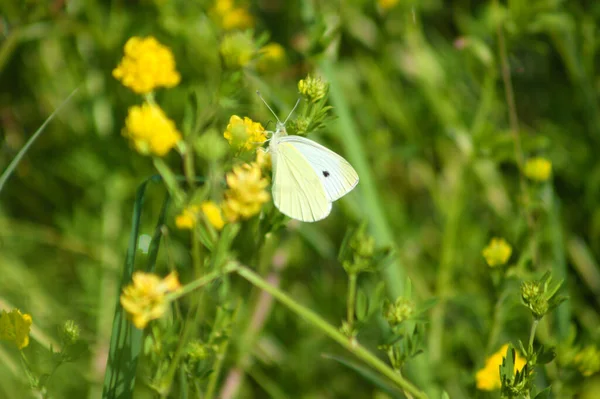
[123, 103, 181, 156]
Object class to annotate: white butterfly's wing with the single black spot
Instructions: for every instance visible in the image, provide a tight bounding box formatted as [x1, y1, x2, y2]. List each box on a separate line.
[279, 136, 358, 202]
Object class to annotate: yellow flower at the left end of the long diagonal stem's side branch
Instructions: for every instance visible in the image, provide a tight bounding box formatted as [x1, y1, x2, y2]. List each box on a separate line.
[121, 272, 181, 329]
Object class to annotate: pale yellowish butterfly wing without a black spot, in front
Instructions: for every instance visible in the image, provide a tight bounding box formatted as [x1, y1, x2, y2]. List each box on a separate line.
[272, 141, 331, 222]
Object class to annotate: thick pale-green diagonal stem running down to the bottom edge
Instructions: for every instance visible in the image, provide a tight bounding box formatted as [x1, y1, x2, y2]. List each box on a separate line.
[236, 266, 427, 399]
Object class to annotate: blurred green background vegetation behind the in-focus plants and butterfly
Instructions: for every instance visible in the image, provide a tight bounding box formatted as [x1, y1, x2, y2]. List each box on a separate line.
[0, 0, 600, 398]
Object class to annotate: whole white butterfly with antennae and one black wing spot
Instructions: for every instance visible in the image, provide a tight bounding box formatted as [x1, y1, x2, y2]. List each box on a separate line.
[259, 93, 358, 222]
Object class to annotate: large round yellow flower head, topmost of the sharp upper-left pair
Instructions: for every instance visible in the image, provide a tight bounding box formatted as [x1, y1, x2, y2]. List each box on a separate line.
[113, 36, 181, 94]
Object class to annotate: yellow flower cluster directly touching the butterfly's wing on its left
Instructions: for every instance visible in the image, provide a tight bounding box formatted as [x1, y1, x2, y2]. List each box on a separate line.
[223, 163, 270, 222]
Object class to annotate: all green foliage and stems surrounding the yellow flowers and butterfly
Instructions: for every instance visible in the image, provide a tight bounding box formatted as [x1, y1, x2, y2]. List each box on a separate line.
[0, 0, 600, 398]
